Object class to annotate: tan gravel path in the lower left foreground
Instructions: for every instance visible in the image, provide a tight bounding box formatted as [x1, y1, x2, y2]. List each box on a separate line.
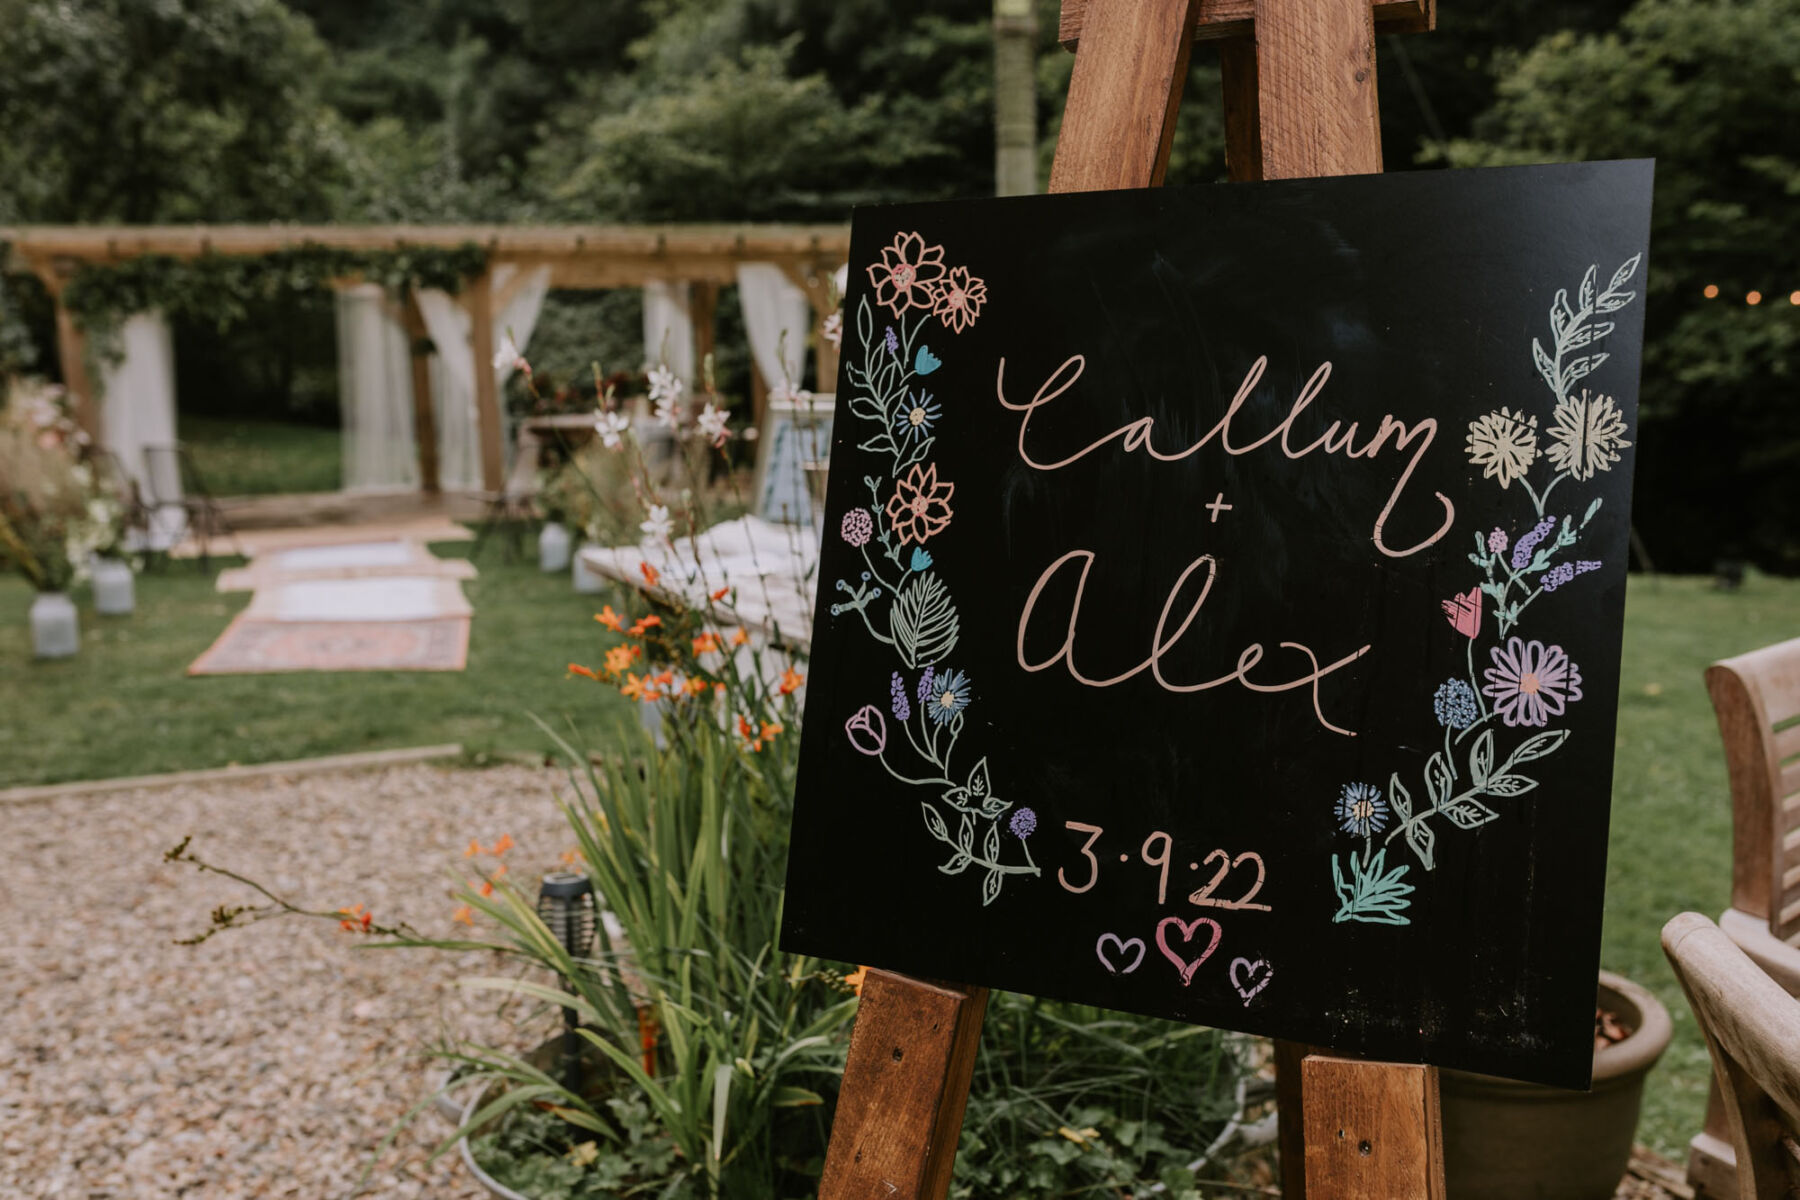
[0, 766, 572, 1200]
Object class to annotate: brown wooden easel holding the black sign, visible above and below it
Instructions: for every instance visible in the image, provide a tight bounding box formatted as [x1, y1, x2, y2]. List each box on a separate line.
[819, 0, 1444, 1200]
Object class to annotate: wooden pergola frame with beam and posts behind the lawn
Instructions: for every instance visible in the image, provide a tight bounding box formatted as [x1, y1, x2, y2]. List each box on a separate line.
[0, 225, 850, 491]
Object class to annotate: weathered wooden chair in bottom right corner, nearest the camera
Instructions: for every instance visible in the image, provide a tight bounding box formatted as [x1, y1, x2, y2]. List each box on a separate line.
[1663, 912, 1800, 1200]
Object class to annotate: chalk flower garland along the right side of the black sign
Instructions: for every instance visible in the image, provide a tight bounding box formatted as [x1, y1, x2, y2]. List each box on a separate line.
[1332, 254, 1643, 925]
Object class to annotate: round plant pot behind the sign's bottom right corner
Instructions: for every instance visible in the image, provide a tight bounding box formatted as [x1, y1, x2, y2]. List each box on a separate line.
[1438, 972, 1672, 1200]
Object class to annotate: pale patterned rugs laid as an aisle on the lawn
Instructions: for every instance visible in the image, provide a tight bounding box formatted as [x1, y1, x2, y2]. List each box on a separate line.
[187, 540, 475, 675]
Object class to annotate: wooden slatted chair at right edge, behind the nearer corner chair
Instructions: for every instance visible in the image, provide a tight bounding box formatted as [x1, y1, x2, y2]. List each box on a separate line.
[1688, 639, 1800, 1200]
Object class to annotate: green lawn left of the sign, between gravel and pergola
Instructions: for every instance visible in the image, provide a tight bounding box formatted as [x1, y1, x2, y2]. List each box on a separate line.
[0, 543, 630, 788]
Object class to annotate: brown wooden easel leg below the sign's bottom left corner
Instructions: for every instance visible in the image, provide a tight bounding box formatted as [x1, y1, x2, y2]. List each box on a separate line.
[819, 972, 988, 1200]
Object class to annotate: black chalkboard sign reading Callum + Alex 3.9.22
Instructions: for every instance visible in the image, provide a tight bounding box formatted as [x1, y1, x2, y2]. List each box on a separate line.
[783, 162, 1651, 1087]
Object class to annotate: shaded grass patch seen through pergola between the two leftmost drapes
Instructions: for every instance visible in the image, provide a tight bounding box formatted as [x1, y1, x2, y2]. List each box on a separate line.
[180, 412, 344, 497]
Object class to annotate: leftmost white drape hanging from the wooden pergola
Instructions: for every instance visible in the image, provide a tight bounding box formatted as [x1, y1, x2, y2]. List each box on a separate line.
[101, 311, 187, 549]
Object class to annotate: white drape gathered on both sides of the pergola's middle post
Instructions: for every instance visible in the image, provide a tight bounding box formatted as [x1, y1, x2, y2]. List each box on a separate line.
[418, 263, 551, 489]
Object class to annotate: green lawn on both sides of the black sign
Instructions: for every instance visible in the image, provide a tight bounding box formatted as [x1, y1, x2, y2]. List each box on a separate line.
[0, 557, 1800, 1157]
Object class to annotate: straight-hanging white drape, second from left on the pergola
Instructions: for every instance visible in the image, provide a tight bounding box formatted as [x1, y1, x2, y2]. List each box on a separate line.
[337, 284, 419, 491]
